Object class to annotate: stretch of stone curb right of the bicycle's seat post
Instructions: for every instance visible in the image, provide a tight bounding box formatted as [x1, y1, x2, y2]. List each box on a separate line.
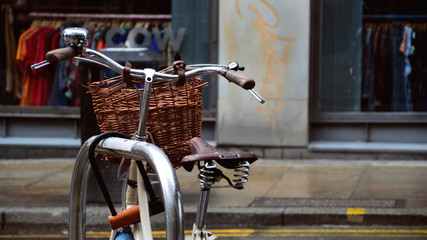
[202, 208, 427, 227]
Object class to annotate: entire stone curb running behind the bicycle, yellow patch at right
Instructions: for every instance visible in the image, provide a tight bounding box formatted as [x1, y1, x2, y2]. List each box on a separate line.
[0, 206, 427, 233]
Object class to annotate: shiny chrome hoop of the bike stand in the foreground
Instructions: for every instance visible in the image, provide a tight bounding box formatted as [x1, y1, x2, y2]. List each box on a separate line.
[69, 137, 184, 240]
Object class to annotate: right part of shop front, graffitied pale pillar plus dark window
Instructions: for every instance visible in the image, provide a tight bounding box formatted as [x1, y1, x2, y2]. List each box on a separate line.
[217, 0, 427, 159]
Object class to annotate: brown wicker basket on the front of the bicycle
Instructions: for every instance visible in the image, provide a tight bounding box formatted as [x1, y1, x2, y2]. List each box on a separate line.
[89, 70, 206, 168]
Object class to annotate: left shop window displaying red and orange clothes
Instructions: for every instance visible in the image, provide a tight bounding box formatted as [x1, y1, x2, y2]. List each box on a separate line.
[0, 0, 171, 107]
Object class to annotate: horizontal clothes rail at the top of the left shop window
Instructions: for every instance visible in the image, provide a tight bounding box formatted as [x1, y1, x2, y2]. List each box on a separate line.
[29, 12, 172, 20]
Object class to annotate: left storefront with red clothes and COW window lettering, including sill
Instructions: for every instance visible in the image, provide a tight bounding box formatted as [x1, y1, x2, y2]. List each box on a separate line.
[0, 0, 176, 158]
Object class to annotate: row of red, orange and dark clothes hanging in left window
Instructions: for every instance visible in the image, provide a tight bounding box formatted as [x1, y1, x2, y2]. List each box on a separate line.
[11, 20, 171, 106]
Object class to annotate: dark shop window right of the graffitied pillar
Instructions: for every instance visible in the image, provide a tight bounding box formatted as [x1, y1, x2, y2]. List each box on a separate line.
[312, 0, 427, 114]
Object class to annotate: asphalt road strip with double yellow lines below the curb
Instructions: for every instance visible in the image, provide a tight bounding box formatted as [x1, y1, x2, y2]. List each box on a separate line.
[0, 226, 427, 240]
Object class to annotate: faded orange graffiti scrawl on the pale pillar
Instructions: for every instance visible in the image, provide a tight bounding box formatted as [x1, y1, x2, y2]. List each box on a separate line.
[235, 0, 295, 140]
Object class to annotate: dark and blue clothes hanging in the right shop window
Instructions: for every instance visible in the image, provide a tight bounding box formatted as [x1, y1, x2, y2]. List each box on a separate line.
[361, 23, 427, 112]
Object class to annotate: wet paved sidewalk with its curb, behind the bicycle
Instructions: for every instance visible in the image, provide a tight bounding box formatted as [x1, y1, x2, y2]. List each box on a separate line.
[0, 159, 427, 231]
